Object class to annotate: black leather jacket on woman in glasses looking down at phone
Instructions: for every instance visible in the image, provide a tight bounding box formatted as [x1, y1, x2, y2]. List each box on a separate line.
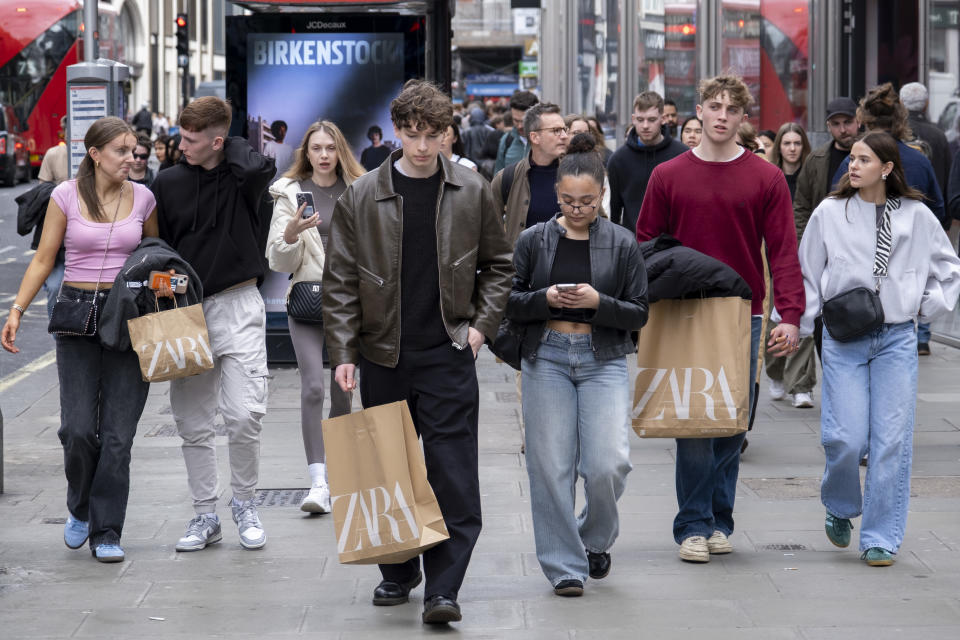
[507, 214, 648, 360]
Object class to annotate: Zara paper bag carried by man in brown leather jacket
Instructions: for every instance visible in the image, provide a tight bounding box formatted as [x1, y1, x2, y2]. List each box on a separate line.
[323, 401, 450, 564]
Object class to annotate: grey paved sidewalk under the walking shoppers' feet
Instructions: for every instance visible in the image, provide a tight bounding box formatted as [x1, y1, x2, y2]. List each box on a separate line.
[0, 345, 960, 640]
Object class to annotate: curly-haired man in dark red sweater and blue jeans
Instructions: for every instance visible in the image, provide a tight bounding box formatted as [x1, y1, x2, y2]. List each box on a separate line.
[637, 76, 805, 562]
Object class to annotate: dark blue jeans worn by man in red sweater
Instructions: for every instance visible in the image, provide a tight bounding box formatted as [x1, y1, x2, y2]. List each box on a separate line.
[673, 316, 763, 544]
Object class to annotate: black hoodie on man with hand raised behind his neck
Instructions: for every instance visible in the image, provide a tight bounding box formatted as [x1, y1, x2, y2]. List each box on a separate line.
[153, 138, 276, 296]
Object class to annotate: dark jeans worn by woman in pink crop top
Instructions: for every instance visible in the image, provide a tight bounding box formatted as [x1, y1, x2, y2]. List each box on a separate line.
[56, 286, 150, 549]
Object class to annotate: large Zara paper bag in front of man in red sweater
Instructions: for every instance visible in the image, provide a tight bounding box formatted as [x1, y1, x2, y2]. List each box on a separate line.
[632, 298, 750, 438]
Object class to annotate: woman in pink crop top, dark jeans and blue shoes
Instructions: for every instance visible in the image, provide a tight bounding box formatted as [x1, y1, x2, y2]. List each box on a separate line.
[0, 117, 159, 562]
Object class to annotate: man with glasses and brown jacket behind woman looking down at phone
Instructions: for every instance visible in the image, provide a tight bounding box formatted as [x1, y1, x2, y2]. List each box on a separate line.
[491, 102, 570, 247]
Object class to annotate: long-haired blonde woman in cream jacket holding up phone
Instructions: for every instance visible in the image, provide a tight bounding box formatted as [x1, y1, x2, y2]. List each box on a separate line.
[267, 120, 364, 513]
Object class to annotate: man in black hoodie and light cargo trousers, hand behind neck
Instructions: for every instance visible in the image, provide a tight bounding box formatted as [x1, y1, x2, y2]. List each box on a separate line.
[153, 97, 276, 551]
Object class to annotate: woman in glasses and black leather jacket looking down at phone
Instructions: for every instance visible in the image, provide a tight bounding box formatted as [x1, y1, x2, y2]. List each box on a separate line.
[507, 133, 647, 596]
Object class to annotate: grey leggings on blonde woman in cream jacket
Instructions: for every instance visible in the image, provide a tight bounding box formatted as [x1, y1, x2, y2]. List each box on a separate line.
[287, 318, 351, 464]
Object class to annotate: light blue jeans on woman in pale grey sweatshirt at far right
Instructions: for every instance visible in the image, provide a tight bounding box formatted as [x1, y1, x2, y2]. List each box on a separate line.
[820, 322, 917, 553]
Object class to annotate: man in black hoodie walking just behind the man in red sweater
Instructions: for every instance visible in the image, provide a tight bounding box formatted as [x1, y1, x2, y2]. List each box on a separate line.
[607, 91, 687, 233]
